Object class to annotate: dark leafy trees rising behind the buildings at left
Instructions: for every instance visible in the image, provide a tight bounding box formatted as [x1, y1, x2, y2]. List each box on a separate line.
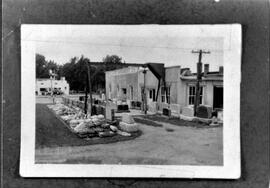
[36, 54, 123, 92]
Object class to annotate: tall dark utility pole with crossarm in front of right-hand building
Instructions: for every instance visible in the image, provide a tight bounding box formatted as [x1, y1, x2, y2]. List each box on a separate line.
[191, 50, 210, 116]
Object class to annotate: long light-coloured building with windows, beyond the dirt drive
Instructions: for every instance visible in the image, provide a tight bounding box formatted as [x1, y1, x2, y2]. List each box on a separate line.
[106, 64, 223, 116]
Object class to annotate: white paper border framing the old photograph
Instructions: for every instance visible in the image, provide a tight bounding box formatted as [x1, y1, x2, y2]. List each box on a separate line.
[20, 24, 242, 179]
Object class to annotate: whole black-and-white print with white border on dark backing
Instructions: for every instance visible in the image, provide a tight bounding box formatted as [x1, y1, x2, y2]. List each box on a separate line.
[20, 24, 241, 179]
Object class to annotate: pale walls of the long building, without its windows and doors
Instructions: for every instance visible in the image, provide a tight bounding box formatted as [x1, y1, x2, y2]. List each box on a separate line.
[106, 66, 223, 114]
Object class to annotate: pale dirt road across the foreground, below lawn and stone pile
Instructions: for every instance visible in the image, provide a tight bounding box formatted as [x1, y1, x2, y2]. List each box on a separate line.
[36, 96, 223, 165]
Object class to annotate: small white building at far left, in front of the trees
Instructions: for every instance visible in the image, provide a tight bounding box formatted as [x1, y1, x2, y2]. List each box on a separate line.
[36, 77, 69, 95]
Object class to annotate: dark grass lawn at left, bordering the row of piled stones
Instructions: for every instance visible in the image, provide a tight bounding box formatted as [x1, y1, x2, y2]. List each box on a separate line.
[36, 104, 142, 148]
